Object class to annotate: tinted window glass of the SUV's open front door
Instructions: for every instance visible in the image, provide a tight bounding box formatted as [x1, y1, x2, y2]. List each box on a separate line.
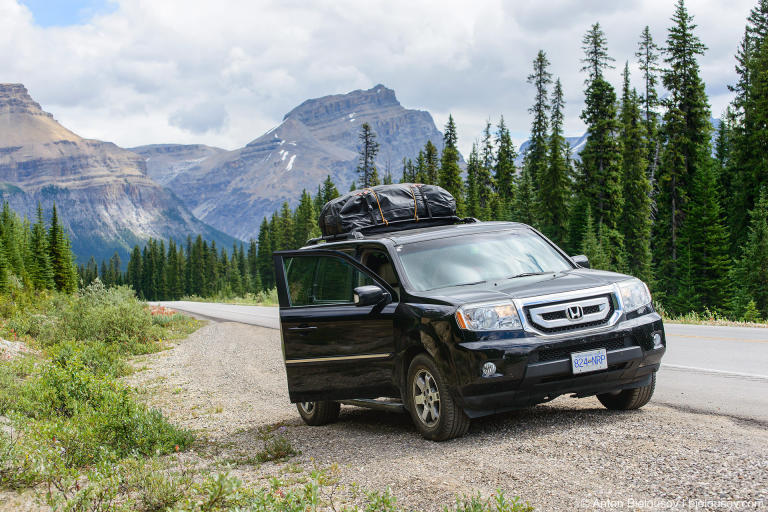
[285, 256, 374, 307]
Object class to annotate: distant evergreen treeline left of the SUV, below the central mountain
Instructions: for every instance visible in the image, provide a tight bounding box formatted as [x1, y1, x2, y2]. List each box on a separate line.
[79, 177, 339, 300]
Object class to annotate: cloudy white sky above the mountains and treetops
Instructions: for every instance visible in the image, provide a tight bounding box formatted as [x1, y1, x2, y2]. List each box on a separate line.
[0, 0, 756, 153]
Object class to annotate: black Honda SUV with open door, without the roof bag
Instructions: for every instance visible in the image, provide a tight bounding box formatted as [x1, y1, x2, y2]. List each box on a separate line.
[274, 222, 666, 440]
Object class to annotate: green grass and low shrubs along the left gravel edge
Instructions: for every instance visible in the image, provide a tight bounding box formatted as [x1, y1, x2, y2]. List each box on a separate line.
[0, 282, 532, 512]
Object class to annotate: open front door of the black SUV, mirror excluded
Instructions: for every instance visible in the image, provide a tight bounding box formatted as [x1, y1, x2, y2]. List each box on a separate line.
[273, 249, 397, 402]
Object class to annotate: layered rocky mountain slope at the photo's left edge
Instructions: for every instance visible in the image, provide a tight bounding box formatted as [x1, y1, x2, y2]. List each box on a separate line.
[0, 84, 234, 262]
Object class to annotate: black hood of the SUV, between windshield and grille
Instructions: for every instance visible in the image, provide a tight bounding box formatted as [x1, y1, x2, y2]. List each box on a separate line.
[420, 269, 631, 305]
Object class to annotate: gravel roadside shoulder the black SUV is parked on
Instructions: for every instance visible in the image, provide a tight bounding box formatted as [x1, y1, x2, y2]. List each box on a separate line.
[121, 323, 768, 511]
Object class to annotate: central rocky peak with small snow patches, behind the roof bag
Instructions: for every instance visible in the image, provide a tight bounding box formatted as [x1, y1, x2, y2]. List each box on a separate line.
[140, 84, 443, 239]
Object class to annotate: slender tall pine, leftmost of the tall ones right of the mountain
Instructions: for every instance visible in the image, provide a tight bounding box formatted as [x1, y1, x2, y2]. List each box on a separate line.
[523, 50, 552, 195]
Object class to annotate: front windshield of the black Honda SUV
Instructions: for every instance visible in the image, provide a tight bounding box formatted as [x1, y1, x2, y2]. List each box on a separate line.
[398, 229, 573, 292]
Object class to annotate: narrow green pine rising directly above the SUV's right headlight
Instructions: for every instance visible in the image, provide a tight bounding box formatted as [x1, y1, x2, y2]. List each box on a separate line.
[619, 63, 652, 282]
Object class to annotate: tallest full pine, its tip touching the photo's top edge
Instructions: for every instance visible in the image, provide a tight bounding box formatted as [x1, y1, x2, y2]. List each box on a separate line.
[653, 0, 711, 304]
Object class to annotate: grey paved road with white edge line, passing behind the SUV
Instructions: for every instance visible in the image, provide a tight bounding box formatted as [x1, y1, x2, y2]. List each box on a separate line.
[154, 302, 768, 425]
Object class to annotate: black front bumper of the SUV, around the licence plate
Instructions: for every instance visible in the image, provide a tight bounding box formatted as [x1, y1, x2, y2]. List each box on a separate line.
[453, 313, 666, 417]
